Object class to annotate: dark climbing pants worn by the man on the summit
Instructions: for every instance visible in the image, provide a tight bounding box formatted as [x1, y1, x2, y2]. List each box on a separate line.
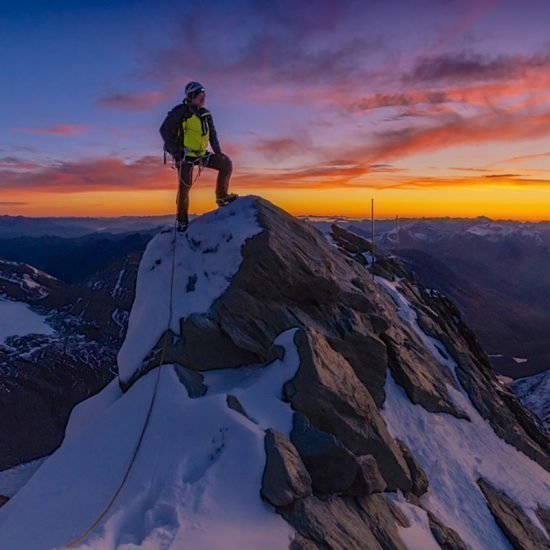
[177, 153, 233, 223]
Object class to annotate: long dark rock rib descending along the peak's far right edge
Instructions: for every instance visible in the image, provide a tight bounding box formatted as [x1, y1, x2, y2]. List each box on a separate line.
[418, 293, 550, 471]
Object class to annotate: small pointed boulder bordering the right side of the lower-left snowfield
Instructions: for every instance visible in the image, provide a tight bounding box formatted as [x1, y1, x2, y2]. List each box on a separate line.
[261, 429, 311, 507]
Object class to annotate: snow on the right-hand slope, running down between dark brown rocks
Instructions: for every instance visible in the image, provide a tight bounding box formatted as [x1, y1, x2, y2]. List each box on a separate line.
[377, 278, 550, 550]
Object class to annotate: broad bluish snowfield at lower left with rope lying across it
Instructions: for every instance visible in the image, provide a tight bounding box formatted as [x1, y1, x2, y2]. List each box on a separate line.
[0, 330, 299, 550]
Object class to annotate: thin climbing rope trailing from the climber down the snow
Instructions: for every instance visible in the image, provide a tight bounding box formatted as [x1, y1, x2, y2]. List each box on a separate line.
[66, 216, 177, 548]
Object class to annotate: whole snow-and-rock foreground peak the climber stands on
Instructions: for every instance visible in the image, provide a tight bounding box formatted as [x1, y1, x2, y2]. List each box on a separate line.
[0, 197, 550, 549]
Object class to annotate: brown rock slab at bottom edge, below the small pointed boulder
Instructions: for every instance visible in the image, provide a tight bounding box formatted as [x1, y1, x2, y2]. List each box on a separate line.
[280, 495, 409, 550]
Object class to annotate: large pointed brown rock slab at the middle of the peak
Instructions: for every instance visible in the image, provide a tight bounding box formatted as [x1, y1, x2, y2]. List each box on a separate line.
[284, 330, 412, 491]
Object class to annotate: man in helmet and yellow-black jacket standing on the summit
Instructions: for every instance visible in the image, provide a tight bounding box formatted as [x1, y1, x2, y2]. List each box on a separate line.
[160, 82, 237, 231]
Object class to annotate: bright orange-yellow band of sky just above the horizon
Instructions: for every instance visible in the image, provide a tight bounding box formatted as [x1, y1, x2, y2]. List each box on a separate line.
[0, 183, 550, 221]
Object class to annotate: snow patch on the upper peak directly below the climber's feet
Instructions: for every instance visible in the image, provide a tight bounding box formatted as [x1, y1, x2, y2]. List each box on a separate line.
[118, 200, 262, 382]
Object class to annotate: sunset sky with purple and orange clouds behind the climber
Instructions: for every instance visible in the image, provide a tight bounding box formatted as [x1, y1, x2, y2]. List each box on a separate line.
[0, 0, 550, 220]
